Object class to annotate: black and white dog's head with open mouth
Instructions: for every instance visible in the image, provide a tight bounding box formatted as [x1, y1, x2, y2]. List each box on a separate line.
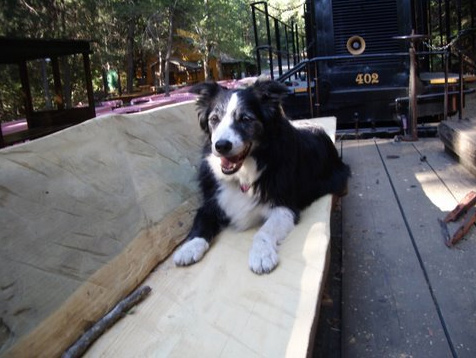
[191, 81, 288, 174]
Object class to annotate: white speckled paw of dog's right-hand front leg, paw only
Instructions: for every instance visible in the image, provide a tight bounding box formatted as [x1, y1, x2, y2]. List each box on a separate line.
[249, 236, 279, 275]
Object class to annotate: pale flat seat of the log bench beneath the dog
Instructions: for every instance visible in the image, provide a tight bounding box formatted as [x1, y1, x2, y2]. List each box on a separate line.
[81, 118, 335, 358]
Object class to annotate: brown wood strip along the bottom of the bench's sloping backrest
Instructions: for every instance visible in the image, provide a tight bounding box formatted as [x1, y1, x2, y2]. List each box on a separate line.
[7, 197, 198, 358]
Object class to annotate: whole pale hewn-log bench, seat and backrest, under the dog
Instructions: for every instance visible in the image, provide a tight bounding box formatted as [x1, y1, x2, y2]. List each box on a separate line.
[0, 102, 335, 357]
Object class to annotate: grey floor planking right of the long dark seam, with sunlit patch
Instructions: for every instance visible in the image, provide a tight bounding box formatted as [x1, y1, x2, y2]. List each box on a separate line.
[379, 139, 476, 357]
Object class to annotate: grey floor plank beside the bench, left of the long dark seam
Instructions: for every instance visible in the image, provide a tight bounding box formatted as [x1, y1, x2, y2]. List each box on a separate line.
[342, 140, 450, 357]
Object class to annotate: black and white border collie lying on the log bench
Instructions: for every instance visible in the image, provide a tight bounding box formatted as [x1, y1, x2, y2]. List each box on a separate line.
[174, 80, 350, 274]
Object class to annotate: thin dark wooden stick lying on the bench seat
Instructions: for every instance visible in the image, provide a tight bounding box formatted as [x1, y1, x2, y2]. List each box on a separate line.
[61, 286, 152, 358]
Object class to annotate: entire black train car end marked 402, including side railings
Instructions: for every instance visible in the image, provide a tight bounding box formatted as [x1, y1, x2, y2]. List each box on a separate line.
[279, 0, 474, 131]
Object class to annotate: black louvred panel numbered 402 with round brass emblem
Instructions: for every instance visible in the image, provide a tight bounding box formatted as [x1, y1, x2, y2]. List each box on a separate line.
[306, 0, 412, 127]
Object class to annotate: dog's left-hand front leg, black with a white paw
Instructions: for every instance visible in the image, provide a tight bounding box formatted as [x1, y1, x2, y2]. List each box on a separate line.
[174, 203, 226, 266]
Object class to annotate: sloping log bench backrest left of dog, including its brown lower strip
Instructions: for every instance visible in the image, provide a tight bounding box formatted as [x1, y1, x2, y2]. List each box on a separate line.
[0, 103, 201, 357]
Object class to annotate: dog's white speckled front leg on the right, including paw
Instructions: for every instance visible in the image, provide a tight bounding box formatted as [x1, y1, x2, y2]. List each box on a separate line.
[249, 206, 295, 274]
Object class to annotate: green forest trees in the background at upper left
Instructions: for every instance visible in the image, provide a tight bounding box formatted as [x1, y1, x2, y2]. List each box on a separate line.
[0, 0, 303, 121]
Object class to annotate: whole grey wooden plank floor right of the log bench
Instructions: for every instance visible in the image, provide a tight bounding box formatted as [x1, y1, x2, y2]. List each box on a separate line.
[342, 138, 476, 357]
